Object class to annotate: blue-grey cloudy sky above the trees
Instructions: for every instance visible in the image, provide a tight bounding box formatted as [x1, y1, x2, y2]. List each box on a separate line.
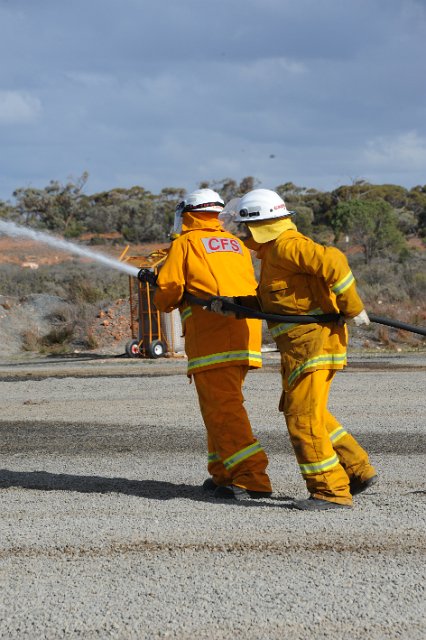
[0, 0, 426, 202]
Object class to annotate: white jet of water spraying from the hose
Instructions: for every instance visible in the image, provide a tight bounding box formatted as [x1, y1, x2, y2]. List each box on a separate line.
[0, 220, 139, 277]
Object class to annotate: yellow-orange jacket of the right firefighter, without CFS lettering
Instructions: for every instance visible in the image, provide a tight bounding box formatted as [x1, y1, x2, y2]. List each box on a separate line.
[258, 230, 364, 390]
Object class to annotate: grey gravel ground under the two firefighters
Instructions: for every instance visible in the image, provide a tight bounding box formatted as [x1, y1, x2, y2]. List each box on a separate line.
[0, 353, 426, 640]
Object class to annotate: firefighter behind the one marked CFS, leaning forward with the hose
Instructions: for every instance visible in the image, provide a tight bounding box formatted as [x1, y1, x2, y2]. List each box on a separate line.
[223, 189, 377, 510]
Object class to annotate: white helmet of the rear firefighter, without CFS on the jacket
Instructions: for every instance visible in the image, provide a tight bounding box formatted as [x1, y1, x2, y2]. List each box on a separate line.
[234, 189, 294, 222]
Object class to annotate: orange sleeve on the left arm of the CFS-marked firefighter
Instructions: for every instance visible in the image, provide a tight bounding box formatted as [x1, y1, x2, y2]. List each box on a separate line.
[154, 238, 185, 313]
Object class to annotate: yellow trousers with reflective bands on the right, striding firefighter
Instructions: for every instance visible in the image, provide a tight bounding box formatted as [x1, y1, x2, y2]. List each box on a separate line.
[280, 369, 376, 505]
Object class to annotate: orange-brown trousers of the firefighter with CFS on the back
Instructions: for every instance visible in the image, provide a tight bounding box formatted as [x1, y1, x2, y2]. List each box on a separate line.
[193, 365, 271, 491]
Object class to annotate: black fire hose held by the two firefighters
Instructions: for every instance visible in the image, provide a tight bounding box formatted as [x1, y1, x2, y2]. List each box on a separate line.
[138, 269, 426, 336]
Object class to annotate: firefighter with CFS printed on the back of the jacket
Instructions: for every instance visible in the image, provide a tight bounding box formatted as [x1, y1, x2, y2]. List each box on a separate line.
[154, 189, 271, 500]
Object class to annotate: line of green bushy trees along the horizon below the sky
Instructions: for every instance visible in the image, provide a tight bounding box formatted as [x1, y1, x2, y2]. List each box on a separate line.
[0, 173, 426, 263]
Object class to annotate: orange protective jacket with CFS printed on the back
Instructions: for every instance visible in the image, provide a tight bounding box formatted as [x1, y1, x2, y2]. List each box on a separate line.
[154, 212, 262, 375]
